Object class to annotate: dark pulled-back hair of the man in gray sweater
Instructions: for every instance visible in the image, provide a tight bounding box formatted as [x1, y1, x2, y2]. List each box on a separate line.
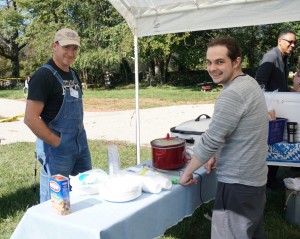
[207, 36, 242, 61]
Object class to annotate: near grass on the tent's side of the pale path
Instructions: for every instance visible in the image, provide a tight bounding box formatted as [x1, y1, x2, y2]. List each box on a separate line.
[0, 140, 300, 239]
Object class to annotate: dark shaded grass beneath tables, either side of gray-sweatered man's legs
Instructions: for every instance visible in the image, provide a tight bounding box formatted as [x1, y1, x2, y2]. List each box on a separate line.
[165, 177, 300, 239]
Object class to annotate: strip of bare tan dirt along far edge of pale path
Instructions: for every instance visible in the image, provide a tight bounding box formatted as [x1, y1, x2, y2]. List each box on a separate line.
[83, 98, 214, 112]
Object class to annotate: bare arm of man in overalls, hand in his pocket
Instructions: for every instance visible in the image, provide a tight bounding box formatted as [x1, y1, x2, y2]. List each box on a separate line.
[24, 100, 60, 147]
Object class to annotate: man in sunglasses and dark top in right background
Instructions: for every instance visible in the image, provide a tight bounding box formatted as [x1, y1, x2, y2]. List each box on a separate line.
[255, 30, 296, 189]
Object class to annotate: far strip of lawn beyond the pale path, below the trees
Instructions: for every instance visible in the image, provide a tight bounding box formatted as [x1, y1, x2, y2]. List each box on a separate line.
[0, 86, 219, 112]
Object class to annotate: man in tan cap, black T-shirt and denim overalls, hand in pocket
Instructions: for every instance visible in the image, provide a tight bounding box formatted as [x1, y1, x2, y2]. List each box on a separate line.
[24, 28, 92, 202]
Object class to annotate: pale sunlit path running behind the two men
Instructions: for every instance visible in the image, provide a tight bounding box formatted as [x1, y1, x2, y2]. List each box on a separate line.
[0, 98, 213, 145]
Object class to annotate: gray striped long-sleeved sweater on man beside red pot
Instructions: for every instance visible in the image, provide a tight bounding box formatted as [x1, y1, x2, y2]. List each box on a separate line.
[194, 75, 268, 186]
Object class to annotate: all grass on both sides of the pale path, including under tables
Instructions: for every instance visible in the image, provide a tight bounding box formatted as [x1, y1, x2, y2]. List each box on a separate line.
[0, 87, 300, 239]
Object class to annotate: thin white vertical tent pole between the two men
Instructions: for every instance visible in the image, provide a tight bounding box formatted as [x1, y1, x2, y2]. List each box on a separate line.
[134, 35, 141, 164]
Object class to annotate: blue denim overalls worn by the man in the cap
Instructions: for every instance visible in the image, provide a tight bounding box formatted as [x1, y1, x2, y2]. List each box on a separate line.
[36, 64, 92, 202]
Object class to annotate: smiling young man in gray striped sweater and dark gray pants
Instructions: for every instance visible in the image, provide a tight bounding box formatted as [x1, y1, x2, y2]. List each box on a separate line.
[180, 37, 268, 239]
